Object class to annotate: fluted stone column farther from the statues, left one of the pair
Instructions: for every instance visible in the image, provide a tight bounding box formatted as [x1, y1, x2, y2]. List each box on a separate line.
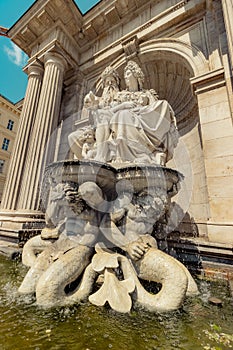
[1, 62, 44, 210]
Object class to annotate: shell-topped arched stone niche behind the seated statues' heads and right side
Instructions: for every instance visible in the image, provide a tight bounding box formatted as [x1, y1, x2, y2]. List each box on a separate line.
[103, 40, 209, 236]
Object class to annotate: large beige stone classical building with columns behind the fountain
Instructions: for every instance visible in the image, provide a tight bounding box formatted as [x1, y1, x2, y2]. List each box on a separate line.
[0, 0, 233, 262]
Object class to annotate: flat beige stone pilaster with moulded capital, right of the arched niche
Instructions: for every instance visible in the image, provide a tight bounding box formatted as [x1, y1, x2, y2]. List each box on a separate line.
[191, 68, 233, 243]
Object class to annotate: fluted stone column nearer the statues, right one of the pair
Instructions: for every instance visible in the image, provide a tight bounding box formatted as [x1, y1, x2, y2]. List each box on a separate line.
[17, 52, 66, 211]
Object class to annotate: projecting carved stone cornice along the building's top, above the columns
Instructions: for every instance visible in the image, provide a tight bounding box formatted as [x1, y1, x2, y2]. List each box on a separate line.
[8, 0, 206, 69]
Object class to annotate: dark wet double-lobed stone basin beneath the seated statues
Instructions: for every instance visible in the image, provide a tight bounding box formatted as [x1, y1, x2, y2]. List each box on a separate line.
[42, 160, 183, 204]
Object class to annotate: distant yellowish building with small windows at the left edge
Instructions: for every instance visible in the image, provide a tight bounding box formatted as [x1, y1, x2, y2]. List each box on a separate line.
[0, 95, 21, 201]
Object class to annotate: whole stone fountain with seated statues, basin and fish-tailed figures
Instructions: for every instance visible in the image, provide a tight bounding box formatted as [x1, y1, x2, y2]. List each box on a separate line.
[19, 61, 198, 313]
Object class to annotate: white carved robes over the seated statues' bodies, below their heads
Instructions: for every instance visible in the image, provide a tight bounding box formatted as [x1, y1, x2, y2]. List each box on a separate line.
[93, 100, 178, 163]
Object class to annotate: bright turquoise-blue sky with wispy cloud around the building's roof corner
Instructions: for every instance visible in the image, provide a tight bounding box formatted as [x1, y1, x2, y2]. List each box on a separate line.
[0, 0, 100, 103]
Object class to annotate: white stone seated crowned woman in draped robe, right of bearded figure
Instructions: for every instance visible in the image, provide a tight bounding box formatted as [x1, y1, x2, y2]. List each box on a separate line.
[109, 61, 178, 165]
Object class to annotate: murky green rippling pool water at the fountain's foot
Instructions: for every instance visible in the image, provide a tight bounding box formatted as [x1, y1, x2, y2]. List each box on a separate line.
[0, 256, 233, 350]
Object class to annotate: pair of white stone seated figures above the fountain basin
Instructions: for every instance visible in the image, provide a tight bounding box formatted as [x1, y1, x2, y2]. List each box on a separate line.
[69, 61, 178, 165]
